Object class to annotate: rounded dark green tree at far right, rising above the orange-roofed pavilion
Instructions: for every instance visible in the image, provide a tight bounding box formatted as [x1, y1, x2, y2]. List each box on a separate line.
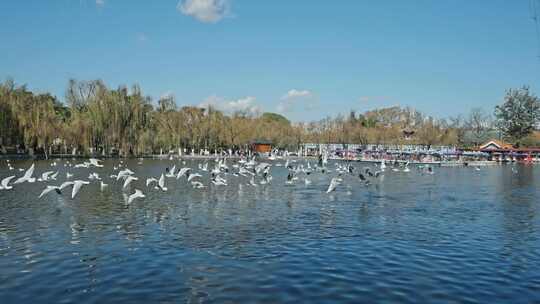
[495, 86, 540, 141]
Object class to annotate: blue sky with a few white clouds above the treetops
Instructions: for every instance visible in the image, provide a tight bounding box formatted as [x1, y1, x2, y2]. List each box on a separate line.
[0, 0, 540, 121]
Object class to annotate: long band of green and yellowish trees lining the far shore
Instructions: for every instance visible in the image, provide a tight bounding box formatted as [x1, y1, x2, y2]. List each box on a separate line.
[0, 79, 540, 156]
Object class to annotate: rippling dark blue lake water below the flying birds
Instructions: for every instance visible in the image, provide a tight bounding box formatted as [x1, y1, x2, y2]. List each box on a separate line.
[0, 160, 540, 303]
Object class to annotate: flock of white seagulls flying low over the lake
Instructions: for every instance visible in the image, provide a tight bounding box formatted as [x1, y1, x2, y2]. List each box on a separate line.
[0, 157, 446, 204]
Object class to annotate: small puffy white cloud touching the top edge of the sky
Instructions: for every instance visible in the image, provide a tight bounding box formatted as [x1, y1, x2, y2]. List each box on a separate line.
[176, 0, 229, 23]
